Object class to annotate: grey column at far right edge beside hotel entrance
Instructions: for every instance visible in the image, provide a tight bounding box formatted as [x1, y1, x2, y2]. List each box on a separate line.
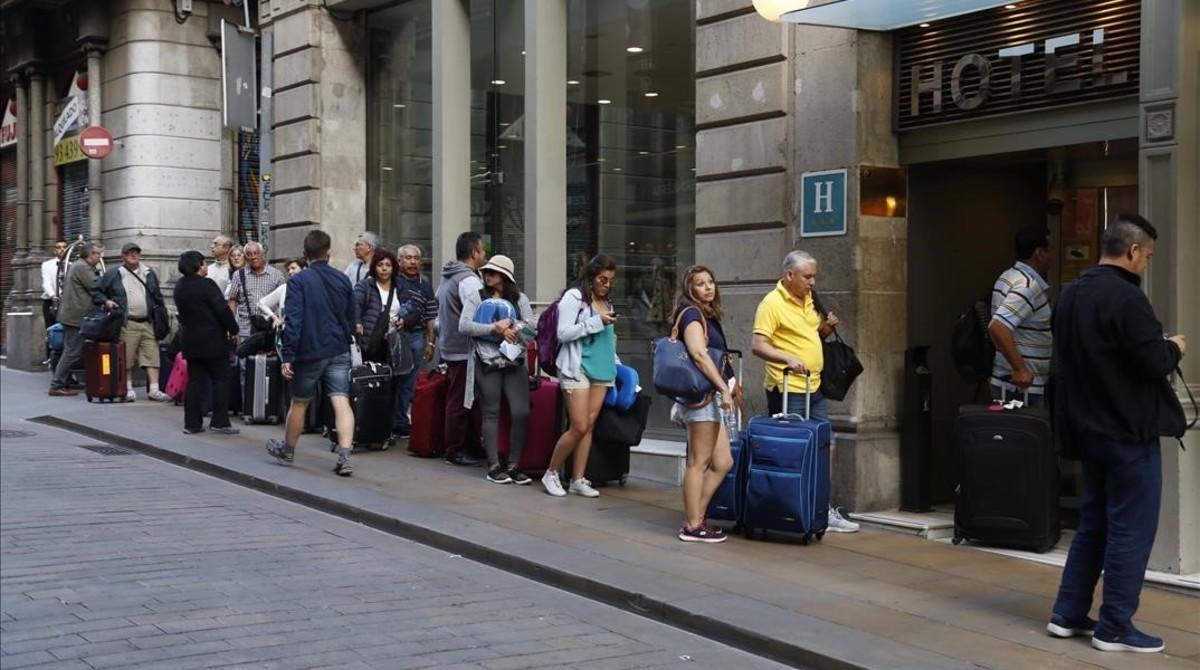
[1138, 0, 1200, 574]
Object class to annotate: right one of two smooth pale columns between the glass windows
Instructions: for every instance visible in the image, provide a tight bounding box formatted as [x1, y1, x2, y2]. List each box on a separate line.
[522, 0, 566, 303]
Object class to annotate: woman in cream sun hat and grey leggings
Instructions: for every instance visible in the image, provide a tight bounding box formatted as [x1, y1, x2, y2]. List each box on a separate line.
[458, 255, 533, 485]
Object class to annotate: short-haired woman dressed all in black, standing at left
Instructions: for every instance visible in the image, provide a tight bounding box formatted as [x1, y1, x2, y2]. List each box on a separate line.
[175, 251, 238, 435]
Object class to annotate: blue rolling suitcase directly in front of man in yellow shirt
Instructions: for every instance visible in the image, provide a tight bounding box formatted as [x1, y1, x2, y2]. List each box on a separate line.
[742, 371, 833, 544]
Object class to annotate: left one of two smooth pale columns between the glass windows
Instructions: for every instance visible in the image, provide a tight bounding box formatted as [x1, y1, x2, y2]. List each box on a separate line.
[432, 0, 470, 276]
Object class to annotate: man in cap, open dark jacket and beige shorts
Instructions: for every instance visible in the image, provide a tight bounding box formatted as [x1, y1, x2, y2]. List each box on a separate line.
[91, 243, 168, 401]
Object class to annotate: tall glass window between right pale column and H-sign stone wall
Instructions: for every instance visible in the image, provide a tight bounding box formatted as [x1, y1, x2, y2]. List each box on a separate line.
[566, 0, 696, 436]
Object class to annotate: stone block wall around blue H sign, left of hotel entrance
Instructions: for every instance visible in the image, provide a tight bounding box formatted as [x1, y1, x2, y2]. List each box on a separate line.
[696, 0, 907, 510]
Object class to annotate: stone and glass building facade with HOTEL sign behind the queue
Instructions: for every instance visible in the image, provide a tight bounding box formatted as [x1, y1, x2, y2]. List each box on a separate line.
[0, 0, 1200, 573]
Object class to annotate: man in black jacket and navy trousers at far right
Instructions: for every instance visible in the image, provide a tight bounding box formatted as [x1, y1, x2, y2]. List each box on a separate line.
[1046, 214, 1187, 652]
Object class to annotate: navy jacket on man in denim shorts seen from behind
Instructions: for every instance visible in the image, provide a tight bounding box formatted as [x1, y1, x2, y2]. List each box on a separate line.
[280, 261, 354, 363]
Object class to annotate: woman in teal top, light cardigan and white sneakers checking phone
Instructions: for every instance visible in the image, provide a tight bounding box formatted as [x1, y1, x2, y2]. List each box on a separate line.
[541, 253, 618, 498]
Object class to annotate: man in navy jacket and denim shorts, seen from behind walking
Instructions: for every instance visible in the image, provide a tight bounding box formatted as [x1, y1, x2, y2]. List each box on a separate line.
[266, 231, 354, 477]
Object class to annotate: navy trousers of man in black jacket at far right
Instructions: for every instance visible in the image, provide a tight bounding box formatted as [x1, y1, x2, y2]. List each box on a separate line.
[1054, 437, 1163, 635]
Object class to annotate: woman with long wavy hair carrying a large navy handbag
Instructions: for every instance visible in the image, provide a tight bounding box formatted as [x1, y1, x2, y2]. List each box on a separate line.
[673, 265, 742, 543]
